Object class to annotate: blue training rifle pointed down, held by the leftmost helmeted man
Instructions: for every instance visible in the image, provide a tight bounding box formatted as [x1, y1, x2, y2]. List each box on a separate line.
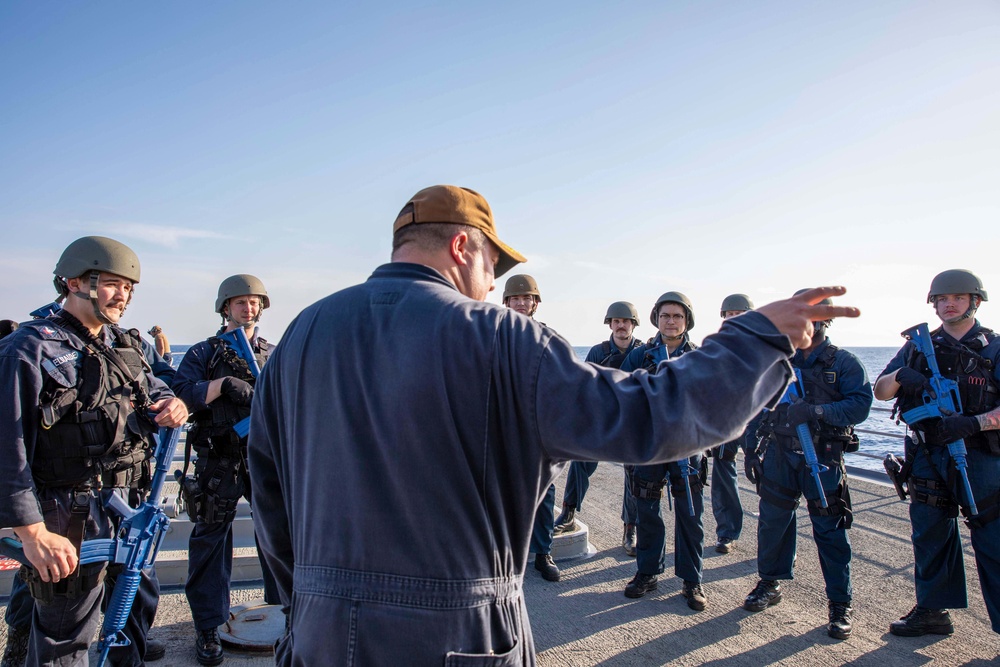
[0, 428, 181, 667]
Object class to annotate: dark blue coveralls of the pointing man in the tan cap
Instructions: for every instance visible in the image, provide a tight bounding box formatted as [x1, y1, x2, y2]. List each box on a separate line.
[249, 262, 804, 667]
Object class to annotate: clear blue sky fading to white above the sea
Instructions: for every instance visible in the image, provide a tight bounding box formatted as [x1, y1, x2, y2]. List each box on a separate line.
[0, 0, 1000, 346]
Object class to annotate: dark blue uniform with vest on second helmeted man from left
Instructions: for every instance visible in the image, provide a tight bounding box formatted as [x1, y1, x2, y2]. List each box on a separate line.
[171, 336, 279, 632]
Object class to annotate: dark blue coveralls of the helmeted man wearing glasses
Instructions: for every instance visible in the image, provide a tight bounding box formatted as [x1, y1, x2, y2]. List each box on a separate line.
[622, 333, 705, 584]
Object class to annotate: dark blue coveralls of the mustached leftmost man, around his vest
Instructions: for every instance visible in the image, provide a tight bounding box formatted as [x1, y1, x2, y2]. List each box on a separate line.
[0, 319, 173, 666]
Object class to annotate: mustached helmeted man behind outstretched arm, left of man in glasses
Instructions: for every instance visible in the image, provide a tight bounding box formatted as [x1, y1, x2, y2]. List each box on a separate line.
[553, 301, 642, 556]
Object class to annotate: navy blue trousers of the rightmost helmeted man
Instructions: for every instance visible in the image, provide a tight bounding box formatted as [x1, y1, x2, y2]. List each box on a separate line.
[910, 447, 1000, 633]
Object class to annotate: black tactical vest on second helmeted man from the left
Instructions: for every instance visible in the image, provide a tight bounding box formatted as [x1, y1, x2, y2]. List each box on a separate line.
[188, 336, 271, 456]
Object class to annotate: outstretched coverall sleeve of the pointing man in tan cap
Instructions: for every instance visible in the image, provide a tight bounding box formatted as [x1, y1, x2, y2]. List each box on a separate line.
[534, 313, 793, 464]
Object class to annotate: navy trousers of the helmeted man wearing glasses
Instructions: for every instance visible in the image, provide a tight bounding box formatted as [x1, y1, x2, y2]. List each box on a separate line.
[633, 454, 705, 583]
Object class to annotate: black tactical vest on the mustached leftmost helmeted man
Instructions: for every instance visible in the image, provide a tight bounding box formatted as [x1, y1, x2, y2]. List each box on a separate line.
[31, 312, 157, 487]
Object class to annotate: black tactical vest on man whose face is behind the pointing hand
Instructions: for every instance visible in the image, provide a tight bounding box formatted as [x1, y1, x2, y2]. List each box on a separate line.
[757, 345, 858, 458]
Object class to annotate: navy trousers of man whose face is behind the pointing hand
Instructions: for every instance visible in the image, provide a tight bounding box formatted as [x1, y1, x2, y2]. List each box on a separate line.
[757, 442, 853, 602]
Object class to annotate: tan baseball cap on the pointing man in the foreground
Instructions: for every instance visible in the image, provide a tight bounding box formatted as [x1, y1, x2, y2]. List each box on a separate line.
[392, 185, 528, 277]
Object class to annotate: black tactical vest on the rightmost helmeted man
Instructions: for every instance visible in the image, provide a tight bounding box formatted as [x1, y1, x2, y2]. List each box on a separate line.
[896, 328, 1000, 454]
